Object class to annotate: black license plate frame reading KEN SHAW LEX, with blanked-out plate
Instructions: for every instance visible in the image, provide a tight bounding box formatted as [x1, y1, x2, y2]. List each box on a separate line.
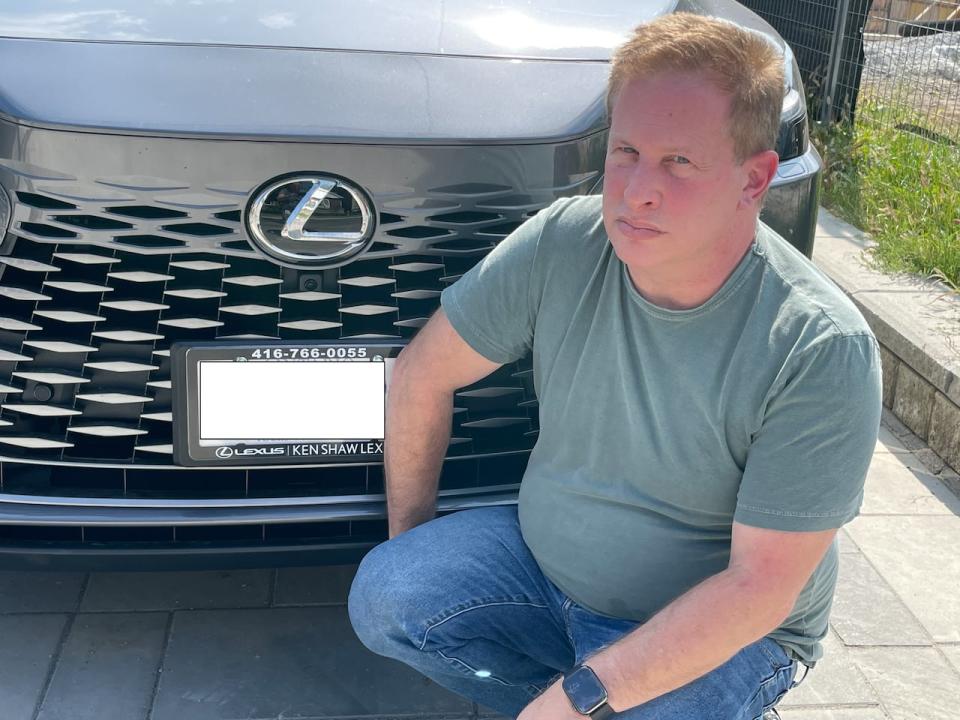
[170, 339, 405, 467]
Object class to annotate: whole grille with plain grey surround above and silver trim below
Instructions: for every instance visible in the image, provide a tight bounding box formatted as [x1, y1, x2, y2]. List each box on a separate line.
[0, 121, 605, 550]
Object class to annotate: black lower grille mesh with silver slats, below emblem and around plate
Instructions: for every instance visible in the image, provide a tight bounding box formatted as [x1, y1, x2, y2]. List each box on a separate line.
[0, 231, 536, 472]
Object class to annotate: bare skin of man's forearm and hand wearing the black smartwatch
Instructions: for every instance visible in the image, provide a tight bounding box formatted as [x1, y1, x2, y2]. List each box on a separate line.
[519, 523, 837, 720]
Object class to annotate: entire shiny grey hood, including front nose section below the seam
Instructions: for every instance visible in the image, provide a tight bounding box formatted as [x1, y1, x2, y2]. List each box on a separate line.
[0, 0, 782, 144]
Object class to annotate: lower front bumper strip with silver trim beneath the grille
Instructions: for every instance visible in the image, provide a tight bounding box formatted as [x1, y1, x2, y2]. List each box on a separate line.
[0, 484, 519, 570]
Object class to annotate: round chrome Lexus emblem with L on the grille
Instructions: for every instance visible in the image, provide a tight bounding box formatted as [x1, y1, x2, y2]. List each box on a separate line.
[247, 174, 374, 267]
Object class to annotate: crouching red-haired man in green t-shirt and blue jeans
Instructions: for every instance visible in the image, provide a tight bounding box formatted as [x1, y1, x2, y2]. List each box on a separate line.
[350, 14, 880, 720]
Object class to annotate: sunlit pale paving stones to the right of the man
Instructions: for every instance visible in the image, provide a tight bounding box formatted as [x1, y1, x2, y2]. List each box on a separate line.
[780, 413, 960, 720]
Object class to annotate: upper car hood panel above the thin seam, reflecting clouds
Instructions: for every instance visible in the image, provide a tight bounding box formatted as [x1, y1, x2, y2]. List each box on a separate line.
[0, 0, 677, 60]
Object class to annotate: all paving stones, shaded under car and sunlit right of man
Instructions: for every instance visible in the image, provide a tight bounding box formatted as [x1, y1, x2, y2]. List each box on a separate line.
[0, 414, 960, 720]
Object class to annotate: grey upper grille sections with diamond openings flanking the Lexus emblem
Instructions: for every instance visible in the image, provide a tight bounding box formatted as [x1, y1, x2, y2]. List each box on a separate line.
[8, 179, 560, 259]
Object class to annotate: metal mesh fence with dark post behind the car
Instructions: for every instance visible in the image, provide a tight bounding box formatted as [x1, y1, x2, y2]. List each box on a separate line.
[741, 0, 960, 146]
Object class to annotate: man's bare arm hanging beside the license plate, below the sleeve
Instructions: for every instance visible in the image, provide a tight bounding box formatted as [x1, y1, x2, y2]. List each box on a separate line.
[384, 309, 500, 537]
